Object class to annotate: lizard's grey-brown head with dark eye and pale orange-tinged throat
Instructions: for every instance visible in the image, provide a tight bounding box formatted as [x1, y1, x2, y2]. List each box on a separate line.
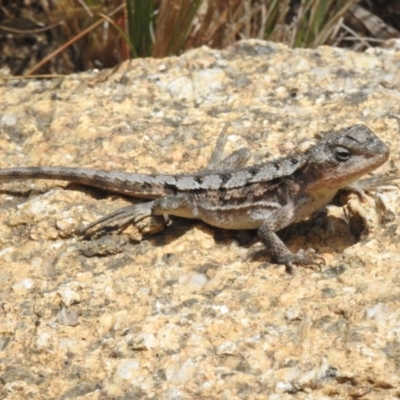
[303, 124, 389, 191]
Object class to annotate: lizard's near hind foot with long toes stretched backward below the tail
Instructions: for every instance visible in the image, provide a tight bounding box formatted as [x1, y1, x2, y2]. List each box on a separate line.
[79, 201, 158, 235]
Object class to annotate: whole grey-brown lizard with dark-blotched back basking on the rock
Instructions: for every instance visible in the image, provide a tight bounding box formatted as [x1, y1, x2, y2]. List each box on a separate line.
[0, 124, 389, 273]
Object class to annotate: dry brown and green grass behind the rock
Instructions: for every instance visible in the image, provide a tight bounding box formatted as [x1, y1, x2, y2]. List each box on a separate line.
[0, 0, 400, 76]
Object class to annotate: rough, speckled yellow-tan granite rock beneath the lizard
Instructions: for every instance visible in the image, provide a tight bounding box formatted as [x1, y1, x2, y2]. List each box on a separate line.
[0, 40, 400, 400]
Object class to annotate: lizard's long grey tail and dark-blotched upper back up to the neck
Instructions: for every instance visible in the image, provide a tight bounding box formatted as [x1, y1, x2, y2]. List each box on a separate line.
[0, 155, 306, 199]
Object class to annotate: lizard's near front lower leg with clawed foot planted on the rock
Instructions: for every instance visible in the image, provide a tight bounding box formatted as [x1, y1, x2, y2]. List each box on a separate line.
[258, 221, 325, 274]
